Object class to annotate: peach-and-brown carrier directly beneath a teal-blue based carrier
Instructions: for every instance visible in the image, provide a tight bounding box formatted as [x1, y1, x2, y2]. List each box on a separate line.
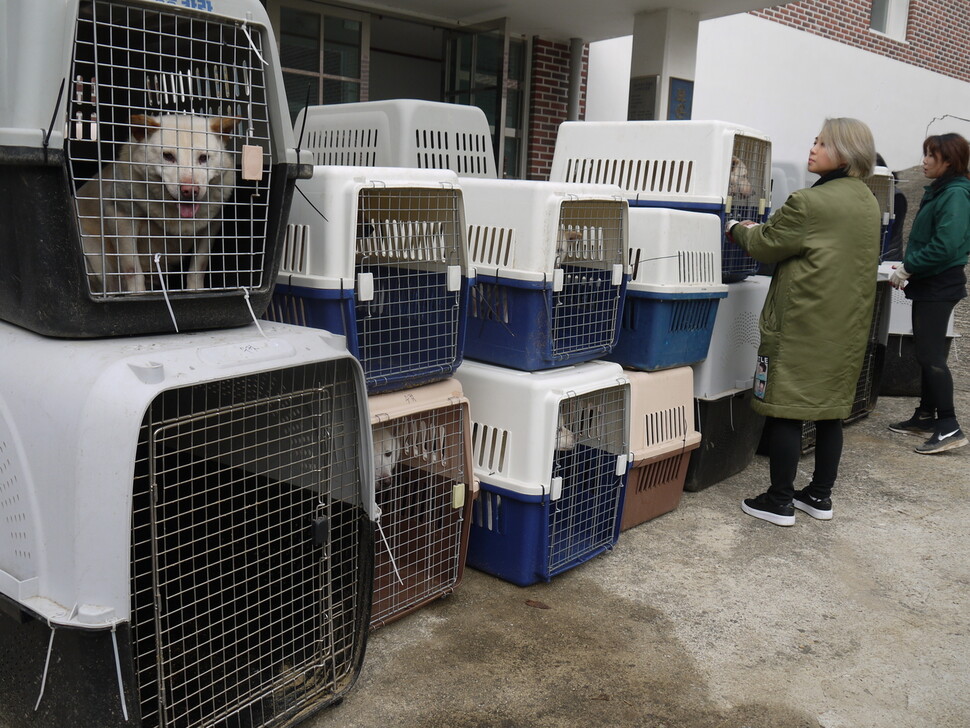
[620, 367, 701, 531]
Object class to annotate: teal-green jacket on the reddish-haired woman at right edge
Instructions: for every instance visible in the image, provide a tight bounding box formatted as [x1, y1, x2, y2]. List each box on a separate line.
[903, 177, 970, 279]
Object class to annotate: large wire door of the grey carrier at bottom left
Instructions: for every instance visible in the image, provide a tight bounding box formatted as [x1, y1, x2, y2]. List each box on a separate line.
[131, 360, 373, 728]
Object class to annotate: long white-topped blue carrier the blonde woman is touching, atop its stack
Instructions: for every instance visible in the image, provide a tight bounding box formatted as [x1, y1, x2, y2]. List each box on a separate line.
[550, 121, 771, 283]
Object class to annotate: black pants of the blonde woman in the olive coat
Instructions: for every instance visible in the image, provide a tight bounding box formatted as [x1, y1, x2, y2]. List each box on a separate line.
[765, 417, 842, 505]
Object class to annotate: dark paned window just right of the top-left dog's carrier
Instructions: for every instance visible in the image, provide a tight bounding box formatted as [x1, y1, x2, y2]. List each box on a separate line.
[276, 2, 367, 120]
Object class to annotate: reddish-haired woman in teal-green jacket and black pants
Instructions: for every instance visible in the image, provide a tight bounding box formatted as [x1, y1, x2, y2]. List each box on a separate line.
[889, 134, 970, 455]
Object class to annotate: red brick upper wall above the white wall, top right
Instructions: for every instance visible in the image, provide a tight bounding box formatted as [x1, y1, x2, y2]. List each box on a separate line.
[751, 0, 970, 81]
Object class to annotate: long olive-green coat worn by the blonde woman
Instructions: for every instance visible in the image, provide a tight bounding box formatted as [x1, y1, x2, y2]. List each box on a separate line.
[731, 177, 881, 420]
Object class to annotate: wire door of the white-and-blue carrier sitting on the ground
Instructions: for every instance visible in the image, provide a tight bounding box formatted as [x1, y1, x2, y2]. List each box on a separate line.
[549, 385, 629, 574]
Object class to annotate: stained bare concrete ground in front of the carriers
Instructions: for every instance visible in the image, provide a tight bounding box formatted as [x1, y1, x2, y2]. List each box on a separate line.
[306, 302, 970, 728]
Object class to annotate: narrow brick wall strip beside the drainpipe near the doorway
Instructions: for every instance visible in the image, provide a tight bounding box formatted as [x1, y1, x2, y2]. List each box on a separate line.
[526, 38, 589, 180]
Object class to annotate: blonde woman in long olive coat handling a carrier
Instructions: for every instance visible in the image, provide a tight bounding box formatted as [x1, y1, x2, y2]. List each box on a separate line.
[726, 118, 881, 526]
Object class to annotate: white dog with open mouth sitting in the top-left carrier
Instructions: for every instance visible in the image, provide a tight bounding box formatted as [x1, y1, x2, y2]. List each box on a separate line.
[77, 114, 239, 292]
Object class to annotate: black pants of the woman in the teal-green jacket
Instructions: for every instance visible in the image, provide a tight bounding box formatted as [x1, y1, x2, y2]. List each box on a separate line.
[913, 301, 957, 420]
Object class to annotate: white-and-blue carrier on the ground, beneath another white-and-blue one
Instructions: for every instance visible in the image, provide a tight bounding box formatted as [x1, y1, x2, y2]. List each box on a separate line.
[457, 361, 630, 586]
